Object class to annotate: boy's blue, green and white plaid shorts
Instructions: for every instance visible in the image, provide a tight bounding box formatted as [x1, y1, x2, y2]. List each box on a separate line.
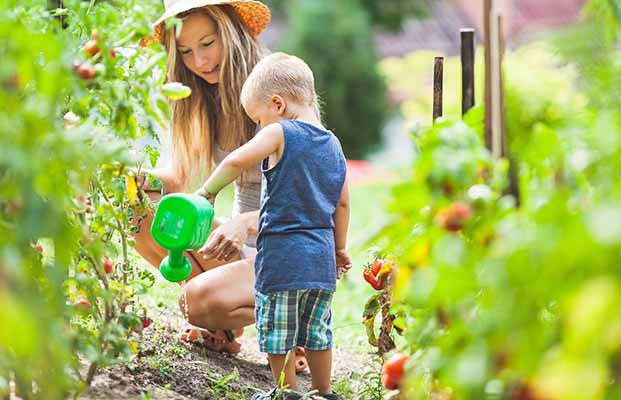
[255, 289, 333, 354]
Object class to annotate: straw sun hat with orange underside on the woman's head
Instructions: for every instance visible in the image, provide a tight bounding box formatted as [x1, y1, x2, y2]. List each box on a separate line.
[140, 0, 271, 46]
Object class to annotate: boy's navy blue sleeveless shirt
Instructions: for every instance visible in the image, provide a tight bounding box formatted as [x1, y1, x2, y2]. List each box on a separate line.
[255, 120, 346, 293]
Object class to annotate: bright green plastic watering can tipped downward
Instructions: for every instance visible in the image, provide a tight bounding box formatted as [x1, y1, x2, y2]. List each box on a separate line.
[151, 193, 214, 282]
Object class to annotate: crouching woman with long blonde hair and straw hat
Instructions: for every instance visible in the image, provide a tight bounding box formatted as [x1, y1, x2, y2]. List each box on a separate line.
[136, 0, 270, 353]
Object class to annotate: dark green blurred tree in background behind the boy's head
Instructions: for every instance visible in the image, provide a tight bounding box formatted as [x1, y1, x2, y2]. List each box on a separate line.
[282, 0, 387, 158]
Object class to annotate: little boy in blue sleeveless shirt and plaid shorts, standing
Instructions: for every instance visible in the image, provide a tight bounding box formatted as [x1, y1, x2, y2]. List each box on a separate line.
[196, 53, 351, 400]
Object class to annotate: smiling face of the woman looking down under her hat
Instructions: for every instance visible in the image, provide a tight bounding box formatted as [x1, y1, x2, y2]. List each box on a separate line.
[177, 13, 222, 84]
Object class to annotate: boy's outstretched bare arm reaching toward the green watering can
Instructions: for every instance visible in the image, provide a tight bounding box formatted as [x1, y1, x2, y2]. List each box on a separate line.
[196, 124, 285, 198]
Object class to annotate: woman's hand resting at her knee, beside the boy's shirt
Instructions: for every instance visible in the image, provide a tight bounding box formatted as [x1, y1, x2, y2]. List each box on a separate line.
[198, 218, 248, 261]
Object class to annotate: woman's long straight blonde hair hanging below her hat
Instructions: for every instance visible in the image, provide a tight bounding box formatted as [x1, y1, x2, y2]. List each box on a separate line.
[163, 5, 264, 190]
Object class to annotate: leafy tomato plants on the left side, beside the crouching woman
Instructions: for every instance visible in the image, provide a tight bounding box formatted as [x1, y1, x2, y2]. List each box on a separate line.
[0, 0, 168, 399]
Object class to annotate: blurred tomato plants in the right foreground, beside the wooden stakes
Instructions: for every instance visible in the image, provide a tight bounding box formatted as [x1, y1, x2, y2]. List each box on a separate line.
[380, 0, 621, 399]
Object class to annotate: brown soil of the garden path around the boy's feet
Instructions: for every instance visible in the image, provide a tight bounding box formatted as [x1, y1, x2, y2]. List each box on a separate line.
[80, 326, 370, 400]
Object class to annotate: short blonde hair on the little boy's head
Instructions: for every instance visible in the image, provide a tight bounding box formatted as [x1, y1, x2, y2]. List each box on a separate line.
[240, 53, 319, 113]
